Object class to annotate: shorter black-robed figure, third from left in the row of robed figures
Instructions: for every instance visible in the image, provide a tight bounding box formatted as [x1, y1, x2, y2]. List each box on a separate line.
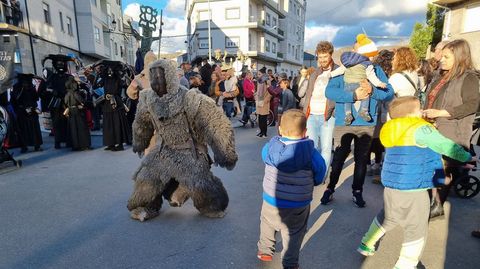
[64, 77, 91, 151]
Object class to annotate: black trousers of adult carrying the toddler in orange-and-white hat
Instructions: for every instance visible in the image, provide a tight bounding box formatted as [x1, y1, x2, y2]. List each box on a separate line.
[328, 126, 374, 191]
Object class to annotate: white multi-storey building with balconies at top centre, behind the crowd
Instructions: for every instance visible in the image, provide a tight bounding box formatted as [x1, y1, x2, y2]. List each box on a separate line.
[185, 0, 306, 76]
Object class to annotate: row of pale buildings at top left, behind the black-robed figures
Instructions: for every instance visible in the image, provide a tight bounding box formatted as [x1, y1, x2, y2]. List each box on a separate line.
[0, 0, 131, 75]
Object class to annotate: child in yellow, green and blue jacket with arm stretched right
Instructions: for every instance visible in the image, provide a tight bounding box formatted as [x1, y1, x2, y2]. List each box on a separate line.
[357, 96, 473, 268]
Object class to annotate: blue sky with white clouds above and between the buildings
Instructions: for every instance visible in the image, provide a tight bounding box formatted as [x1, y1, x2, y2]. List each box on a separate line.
[122, 0, 428, 51]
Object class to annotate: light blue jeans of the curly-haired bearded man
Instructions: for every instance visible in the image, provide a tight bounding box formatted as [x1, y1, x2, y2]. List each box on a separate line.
[307, 114, 335, 167]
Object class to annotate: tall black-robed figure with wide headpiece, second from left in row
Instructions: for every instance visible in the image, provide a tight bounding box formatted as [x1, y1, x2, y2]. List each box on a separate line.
[47, 60, 71, 149]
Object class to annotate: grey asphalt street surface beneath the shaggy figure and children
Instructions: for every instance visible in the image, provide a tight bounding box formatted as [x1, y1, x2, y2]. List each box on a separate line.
[0, 123, 480, 269]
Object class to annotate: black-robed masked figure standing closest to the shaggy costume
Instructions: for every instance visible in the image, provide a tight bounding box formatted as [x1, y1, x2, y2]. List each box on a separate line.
[97, 61, 132, 151]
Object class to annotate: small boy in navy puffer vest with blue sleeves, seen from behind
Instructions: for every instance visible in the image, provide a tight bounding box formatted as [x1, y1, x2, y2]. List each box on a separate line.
[257, 109, 326, 268]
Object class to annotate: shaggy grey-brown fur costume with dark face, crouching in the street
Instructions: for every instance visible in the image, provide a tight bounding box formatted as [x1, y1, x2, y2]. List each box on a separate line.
[127, 60, 238, 221]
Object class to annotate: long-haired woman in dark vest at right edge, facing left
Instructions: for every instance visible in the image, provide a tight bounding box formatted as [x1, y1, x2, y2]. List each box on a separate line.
[423, 39, 480, 218]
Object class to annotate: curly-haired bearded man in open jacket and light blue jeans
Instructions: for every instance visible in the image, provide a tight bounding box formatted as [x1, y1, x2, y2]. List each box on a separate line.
[303, 41, 338, 173]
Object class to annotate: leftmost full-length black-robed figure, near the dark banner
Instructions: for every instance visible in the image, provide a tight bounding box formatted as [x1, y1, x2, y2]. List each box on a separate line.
[10, 74, 43, 153]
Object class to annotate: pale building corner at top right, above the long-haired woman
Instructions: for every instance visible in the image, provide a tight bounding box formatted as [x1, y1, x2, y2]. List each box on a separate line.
[431, 0, 480, 69]
